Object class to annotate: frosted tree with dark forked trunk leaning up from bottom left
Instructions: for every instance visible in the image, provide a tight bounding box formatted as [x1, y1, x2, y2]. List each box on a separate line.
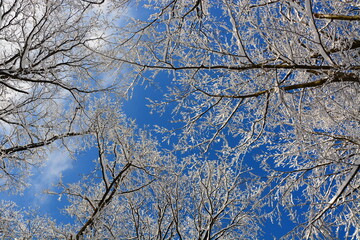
[46, 102, 164, 239]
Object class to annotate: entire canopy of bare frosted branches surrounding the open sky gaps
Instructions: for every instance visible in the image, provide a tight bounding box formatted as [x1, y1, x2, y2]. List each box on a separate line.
[1, 0, 360, 239]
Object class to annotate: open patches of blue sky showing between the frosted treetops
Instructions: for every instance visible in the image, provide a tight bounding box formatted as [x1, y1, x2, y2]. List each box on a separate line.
[0, 0, 356, 239]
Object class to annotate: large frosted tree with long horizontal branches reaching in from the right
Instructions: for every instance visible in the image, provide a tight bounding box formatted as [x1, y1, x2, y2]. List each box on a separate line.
[110, 0, 360, 239]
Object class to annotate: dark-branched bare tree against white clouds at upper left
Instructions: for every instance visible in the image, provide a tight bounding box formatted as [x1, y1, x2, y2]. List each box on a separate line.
[0, 0, 129, 190]
